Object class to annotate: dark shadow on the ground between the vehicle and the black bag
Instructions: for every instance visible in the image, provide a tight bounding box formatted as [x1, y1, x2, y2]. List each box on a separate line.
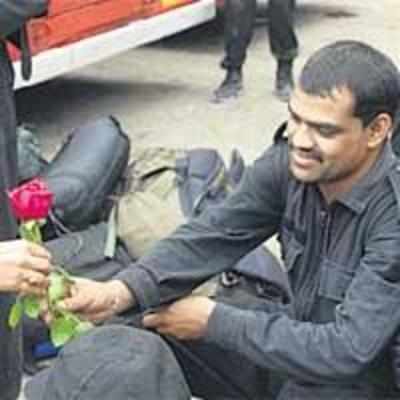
[16, 77, 187, 136]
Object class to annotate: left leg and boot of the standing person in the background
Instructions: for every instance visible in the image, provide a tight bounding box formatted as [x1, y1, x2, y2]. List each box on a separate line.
[214, 0, 257, 102]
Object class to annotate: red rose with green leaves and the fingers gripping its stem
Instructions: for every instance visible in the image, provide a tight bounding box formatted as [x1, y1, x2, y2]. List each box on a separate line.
[6, 179, 92, 346]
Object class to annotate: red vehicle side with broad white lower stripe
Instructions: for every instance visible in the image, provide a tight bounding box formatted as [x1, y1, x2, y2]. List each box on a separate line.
[9, 0, 216, 88]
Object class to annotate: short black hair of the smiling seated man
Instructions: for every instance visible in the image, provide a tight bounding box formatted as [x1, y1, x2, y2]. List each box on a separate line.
[299, 40, 400, 126]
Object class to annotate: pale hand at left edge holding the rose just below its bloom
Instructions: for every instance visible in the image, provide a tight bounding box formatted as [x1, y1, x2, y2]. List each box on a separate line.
[0, 240, 51, 295]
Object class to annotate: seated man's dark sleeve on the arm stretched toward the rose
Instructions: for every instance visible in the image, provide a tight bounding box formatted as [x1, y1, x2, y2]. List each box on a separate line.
[116, 143, 288, 309]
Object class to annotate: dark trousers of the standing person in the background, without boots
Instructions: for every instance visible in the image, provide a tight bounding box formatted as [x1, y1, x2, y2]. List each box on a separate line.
[221, 0, 298, 69]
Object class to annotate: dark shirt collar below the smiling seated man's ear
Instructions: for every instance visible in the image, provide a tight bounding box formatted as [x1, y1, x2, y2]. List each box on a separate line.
[337, 142, 397, 214]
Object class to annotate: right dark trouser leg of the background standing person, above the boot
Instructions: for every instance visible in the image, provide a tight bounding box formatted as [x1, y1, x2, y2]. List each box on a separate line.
[268, 0, 298, 60]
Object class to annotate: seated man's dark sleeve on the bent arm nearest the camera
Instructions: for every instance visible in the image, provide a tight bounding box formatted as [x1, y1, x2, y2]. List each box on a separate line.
[206, 200, 400, 383]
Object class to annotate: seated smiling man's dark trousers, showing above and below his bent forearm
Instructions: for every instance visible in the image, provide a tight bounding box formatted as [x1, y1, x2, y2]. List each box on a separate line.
[145, 278, 390, 400]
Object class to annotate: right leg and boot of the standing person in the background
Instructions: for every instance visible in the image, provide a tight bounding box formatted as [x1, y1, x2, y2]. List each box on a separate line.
[268, 0, 298, 101]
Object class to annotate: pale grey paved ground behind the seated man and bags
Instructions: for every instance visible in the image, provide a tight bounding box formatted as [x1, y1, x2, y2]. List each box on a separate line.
[14, 0, 400, 398]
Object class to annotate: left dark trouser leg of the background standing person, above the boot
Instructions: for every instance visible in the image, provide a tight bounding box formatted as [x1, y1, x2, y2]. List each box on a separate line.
[222, 0, 257, 69]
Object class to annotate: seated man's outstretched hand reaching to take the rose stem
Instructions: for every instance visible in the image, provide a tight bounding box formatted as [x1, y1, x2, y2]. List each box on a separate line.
[60, 278, 134, 323]
